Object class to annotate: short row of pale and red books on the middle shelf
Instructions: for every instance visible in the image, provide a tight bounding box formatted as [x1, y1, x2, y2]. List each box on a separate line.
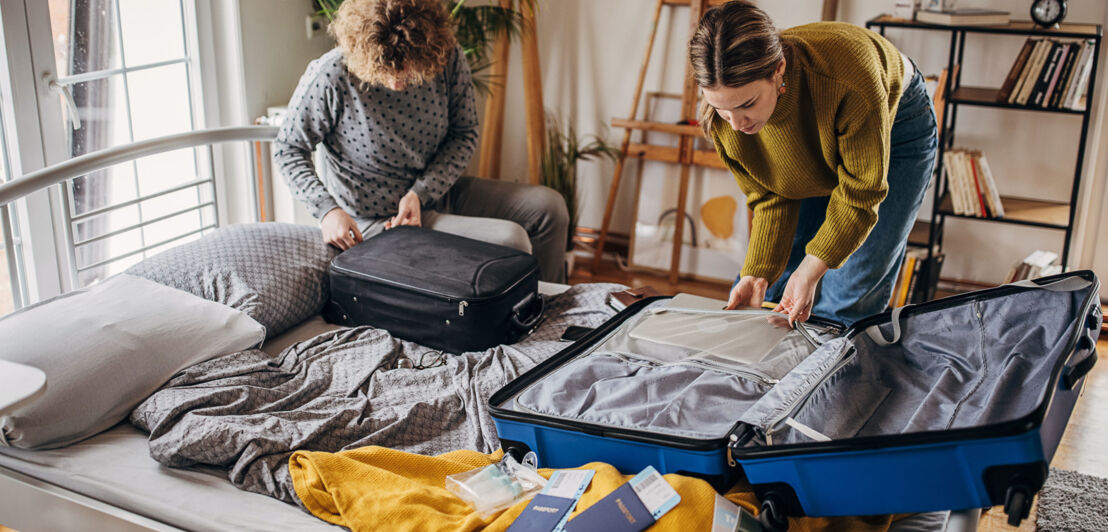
[943, 149, 1004, 218]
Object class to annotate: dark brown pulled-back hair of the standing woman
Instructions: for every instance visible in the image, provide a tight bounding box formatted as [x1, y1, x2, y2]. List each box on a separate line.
[689, 0, 786, 137]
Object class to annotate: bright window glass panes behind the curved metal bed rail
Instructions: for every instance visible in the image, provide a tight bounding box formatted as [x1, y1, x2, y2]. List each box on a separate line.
[49, 0, 217, 286]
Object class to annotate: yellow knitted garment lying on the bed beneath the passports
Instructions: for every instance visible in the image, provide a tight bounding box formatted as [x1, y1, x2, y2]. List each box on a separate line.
[288, 446, 903, 532]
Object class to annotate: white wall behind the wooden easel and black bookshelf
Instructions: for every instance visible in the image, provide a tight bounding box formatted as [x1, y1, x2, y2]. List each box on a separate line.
[502, 0, 1108, 283]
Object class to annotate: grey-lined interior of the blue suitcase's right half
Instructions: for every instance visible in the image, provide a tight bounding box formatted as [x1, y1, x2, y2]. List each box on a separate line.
[749, 282, 1085, 444]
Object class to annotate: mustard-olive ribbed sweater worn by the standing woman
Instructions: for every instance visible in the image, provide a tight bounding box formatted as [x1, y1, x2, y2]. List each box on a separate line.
[711, 22, 904, 283]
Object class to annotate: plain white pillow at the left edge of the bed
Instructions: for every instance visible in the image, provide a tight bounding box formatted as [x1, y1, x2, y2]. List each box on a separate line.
[0, 275, 266, 449]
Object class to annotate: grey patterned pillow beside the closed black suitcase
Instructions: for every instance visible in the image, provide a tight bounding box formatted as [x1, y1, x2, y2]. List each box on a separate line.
[126, 223, 338, 338]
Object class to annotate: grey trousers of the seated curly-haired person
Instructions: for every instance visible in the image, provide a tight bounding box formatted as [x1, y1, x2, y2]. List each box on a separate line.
[355, 177, 570, 283]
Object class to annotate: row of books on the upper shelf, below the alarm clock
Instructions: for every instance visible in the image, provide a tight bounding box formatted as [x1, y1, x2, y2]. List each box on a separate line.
[996, 38, 1094, 111]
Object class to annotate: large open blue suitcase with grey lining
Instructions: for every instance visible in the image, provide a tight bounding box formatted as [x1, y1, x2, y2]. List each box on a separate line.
[490, 270, 1101, 525]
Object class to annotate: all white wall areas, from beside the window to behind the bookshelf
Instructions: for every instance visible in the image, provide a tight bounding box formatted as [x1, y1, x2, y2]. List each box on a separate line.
[223, 0, 1108, 283]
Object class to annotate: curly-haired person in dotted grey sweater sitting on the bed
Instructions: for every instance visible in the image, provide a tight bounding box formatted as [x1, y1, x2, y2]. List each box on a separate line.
[275, 0, 568, 283]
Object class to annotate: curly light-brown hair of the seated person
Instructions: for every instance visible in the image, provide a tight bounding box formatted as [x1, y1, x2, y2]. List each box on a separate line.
[328, 0, 458, 85]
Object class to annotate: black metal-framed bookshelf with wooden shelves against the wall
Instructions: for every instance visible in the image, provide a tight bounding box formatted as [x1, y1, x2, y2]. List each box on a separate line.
[865, 16, 1102, 300]
